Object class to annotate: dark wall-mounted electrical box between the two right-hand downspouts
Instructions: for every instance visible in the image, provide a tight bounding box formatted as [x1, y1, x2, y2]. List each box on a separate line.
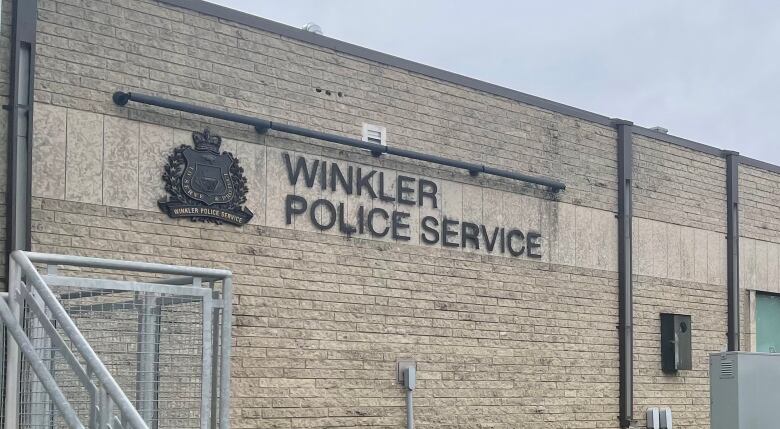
[661, 313, 693, 372]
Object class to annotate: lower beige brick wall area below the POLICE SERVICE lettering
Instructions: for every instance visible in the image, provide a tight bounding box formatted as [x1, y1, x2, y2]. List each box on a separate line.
[34, 198, 617, 429]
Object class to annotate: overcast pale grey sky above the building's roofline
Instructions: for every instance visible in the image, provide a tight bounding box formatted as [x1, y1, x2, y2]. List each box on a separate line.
[211, 0, 780, 164]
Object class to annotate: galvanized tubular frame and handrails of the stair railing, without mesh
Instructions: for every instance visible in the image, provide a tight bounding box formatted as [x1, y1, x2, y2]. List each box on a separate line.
[0, 251, 232, 429]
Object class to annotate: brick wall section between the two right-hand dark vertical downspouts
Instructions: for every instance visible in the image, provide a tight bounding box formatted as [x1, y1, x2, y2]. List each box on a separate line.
[633, 136, 726, 428]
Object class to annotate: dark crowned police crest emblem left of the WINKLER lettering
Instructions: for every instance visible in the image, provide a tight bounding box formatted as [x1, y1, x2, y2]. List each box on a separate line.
[157, 128, 253, 226]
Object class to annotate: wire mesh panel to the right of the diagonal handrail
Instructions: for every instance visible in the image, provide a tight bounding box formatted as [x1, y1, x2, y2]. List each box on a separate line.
[61, 287, 203, 429]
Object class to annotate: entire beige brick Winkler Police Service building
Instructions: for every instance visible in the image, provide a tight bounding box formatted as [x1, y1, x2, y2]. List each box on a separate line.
[0, 0, 780, 429]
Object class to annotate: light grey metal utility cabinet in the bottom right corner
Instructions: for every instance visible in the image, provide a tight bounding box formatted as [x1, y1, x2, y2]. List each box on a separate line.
[710, 352, 780, 429]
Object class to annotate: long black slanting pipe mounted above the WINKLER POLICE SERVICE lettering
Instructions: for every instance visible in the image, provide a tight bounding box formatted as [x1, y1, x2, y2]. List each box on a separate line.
[113, 91, 566, 192]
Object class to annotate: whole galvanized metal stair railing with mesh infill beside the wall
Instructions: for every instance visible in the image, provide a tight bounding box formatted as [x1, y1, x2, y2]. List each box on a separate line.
[0, 251, 232, 429]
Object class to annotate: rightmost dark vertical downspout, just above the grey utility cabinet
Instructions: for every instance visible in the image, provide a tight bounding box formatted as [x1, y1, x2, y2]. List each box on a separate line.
[722, 151, 740, 351]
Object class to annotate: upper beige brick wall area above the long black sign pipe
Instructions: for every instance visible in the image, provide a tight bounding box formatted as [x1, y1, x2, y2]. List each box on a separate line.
[36, 0, 616, 210]
